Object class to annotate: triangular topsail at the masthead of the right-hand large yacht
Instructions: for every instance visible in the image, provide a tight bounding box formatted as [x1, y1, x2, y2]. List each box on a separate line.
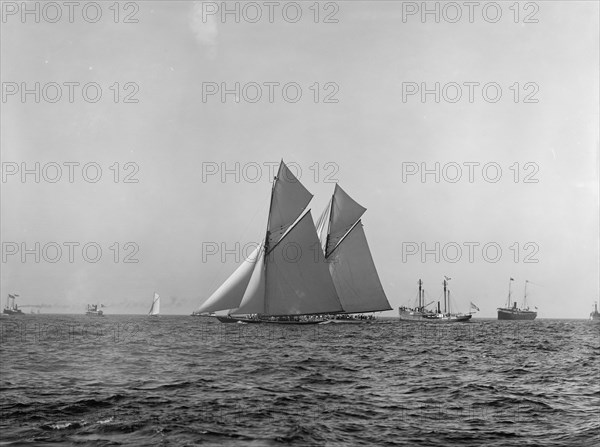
[325, 184, 367, 257]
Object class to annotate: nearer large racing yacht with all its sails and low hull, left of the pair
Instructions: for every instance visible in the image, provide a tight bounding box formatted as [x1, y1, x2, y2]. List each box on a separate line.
[197, 161, 343, 324]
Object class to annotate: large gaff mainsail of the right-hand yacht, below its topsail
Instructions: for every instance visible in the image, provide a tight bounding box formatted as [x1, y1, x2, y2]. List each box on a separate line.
[327, 221, 391, 313]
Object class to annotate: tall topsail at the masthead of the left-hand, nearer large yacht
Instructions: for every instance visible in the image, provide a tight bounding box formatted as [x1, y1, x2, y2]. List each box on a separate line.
[267, 161, 312, 247]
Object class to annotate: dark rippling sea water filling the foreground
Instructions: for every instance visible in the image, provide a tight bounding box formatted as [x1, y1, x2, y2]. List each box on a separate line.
[0, 315, 600, 446]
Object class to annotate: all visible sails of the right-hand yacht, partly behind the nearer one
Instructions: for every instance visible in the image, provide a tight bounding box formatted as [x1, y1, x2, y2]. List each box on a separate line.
[319, 184, 392, 313]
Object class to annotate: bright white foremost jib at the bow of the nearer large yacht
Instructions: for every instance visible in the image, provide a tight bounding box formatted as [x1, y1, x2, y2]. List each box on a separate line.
[198, 245, 262, 312]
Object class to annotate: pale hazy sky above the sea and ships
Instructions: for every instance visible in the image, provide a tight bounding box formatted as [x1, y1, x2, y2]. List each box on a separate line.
[0, 1, 600, 318]
